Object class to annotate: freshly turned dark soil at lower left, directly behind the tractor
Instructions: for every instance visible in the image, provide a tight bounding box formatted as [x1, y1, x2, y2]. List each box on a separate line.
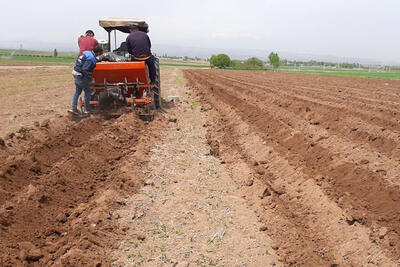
[0, 113, 164, 266]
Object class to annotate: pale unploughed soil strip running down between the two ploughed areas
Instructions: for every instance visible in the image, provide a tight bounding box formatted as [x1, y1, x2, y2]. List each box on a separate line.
[108, 69, 280, 267]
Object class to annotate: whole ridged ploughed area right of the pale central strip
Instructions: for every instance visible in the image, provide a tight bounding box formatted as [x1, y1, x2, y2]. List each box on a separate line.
[185, 70, 400, 266]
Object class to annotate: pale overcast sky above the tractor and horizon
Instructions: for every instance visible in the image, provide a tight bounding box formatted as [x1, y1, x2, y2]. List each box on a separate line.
[0, 0, 400, 62]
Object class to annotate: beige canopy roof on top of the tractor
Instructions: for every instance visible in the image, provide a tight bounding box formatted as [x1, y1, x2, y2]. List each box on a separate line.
[99, 18, 149, 33]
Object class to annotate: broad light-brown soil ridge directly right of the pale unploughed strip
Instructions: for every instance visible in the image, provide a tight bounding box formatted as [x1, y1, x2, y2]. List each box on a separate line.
[203, 89, 394, 266]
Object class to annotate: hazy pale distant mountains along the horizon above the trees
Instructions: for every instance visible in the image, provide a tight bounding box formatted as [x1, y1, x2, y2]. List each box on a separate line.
[0, 41, 400, 66]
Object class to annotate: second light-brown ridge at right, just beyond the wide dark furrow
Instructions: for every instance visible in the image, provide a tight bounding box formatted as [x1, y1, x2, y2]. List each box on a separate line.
[190, 71, 400, 185]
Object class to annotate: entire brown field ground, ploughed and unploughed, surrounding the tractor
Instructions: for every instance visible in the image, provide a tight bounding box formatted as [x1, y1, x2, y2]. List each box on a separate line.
[0, 67, 400, 266]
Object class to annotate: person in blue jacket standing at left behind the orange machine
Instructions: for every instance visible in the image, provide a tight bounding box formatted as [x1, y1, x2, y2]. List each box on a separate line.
[69, 46, 103, 115]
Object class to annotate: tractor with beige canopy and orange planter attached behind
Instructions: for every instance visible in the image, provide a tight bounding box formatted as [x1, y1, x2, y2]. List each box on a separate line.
[78, 18, 161, 121]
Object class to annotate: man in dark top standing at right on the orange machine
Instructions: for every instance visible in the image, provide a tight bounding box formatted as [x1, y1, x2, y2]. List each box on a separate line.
[126, 25, 161, 109]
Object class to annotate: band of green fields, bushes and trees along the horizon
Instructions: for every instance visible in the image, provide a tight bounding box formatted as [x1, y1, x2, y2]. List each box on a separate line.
[0, 49, 400, 79]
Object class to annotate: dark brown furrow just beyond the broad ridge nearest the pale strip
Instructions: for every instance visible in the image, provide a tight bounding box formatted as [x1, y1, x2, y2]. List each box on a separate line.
[186, 70, 400, 264]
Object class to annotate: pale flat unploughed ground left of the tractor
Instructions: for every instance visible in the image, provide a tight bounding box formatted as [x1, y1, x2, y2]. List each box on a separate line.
[0, 66, 75, 137]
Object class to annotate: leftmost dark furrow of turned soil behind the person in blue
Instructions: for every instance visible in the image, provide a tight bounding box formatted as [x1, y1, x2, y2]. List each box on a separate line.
[0, 119, 108, 205]
